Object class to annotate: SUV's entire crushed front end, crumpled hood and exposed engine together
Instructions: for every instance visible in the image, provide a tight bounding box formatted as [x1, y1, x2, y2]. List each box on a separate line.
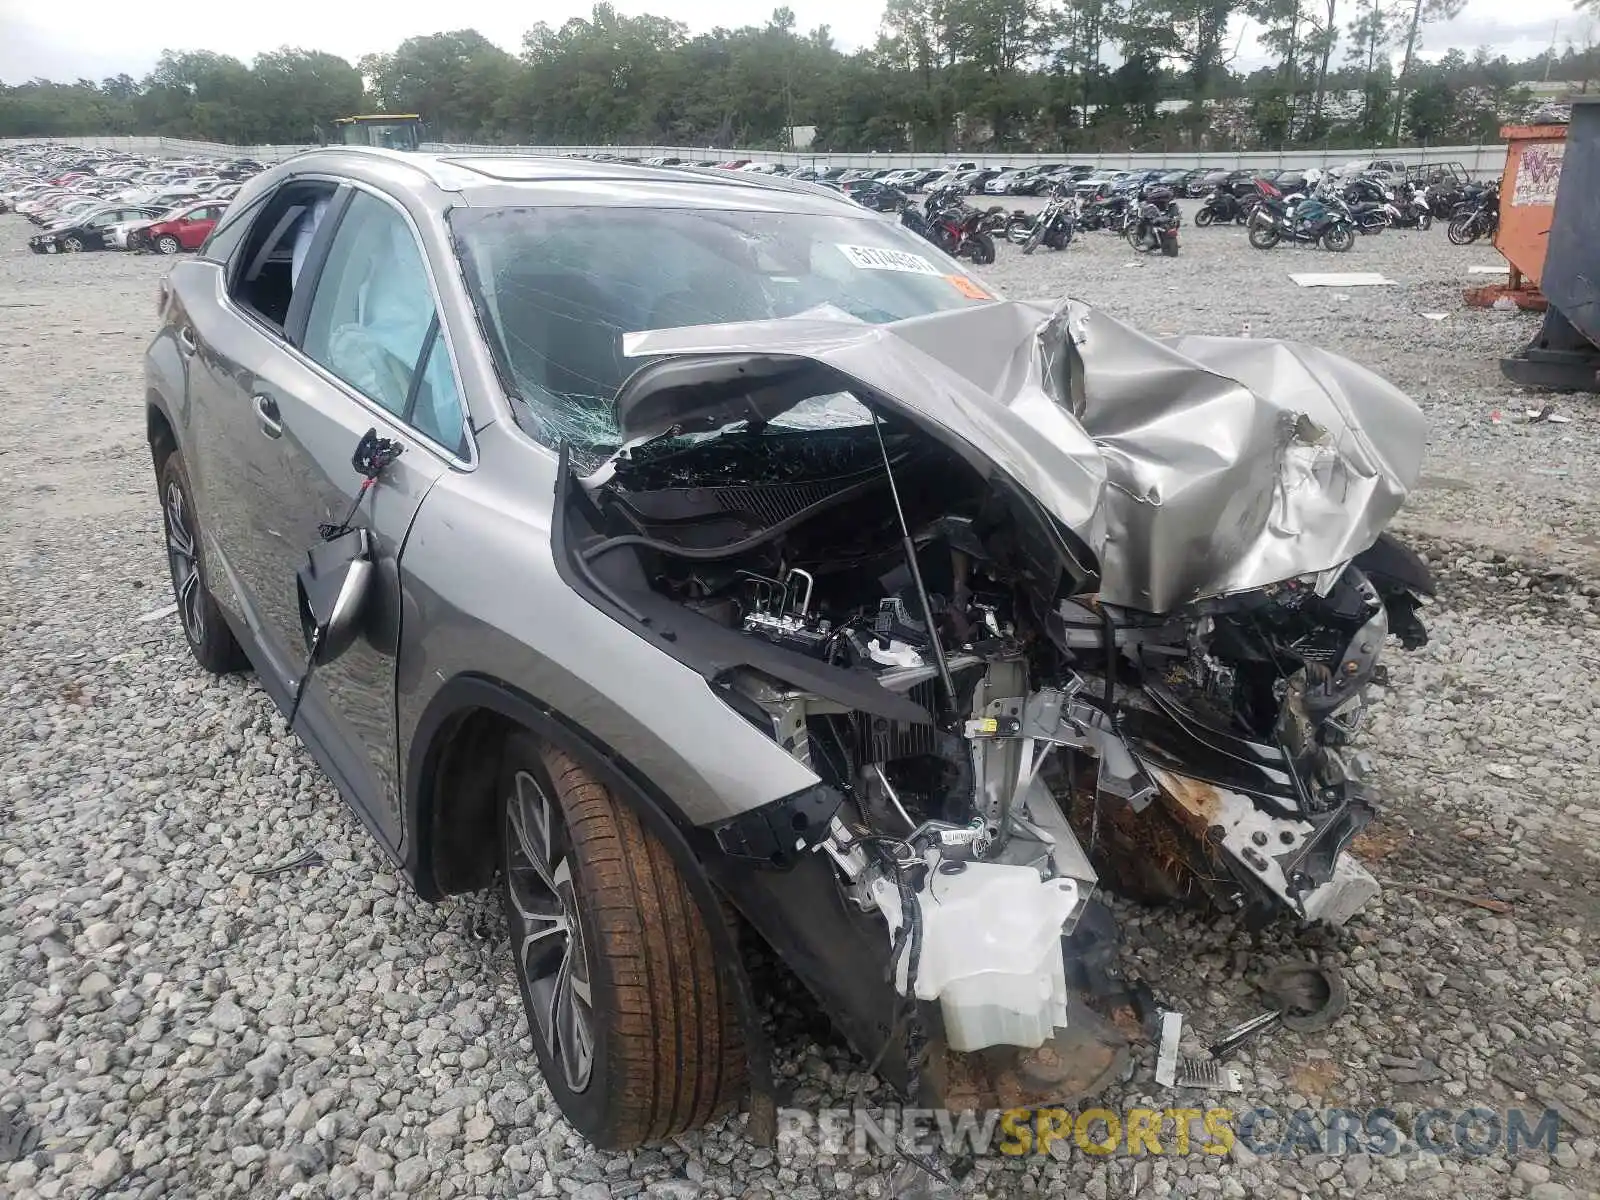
[557, 304, 1432, 1107]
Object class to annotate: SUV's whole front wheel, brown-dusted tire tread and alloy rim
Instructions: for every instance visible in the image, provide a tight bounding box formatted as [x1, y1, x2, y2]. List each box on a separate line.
[499, 733, 747, 1150]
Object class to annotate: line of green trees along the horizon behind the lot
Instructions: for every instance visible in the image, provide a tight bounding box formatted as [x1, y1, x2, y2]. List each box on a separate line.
[0, 0, 1600, 154]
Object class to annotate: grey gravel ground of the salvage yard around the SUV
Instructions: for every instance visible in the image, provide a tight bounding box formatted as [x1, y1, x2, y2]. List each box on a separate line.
[0, 206, 1600, 1200]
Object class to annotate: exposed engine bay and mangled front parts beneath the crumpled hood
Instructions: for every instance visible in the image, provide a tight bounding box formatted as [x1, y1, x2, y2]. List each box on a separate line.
[562, 300, 1432, 1094]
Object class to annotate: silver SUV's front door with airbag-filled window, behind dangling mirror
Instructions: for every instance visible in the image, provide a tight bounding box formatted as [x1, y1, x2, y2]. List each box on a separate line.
[251, 189, 472, 846]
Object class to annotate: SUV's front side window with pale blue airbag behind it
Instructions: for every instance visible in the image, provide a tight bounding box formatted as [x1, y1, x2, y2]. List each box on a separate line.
[301, 192, 462, 453]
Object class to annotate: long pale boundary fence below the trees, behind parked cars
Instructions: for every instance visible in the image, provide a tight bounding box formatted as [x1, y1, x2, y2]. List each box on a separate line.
[0, 138, 1506, 176]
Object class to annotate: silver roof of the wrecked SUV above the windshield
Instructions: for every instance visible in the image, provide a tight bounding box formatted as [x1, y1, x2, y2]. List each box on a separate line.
[235, 146, 872, 216]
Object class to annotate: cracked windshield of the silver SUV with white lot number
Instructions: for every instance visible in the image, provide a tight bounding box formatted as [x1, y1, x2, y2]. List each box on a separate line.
[450, 206, 992, 459]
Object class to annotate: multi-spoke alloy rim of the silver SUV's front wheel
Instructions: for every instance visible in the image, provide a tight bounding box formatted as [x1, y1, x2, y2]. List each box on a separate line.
[506, 771, 595, 1093]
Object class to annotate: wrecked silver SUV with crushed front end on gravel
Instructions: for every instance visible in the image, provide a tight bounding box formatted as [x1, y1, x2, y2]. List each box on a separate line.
[147, 149, 1432, 1147]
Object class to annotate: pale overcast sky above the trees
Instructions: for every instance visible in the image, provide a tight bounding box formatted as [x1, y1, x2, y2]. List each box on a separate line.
[0, 0, 1600, 83]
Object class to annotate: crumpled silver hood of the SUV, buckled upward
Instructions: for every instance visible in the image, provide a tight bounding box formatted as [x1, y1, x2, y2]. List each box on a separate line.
[616, 301, 1426, 613]
